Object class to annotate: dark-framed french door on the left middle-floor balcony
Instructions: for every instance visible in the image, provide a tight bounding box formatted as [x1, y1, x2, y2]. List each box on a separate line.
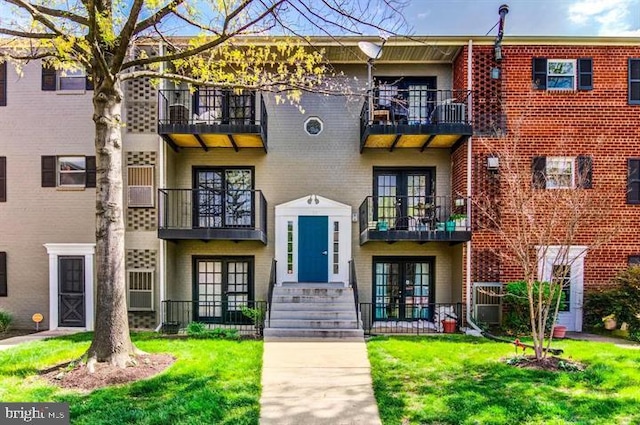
[193, 168, 254, 228]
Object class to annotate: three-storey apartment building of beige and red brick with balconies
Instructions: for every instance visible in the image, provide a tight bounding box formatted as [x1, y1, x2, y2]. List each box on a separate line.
[0, 37, 640, 330]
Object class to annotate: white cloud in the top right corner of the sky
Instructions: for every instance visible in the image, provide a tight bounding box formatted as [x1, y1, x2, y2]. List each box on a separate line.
[568, 0, 640, 36]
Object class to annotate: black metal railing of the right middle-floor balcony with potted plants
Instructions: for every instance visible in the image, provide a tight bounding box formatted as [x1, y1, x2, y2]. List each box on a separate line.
[358, 195, 471, 233]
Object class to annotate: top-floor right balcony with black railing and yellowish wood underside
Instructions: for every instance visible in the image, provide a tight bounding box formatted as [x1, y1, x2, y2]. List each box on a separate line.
[360, 87, 473, 153]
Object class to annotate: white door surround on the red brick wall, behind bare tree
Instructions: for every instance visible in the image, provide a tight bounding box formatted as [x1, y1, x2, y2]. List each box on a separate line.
[536, 245, 588, 332]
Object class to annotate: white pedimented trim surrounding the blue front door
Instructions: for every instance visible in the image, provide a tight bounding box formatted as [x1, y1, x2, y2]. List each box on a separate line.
[275, 194, 352, 286]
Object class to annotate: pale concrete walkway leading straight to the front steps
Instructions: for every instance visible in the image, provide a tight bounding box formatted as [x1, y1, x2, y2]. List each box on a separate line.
[260, 340, 381, 425]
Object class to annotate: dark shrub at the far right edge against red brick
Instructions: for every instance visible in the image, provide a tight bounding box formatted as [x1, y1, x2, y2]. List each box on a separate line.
[584, 266, 640, 341]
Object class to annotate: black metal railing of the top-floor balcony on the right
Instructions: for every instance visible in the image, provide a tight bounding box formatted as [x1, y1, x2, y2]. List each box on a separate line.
[361, 86, 471, 125]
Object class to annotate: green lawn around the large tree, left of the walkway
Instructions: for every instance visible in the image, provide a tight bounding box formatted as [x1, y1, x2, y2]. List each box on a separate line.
[0, 333, 262, 425]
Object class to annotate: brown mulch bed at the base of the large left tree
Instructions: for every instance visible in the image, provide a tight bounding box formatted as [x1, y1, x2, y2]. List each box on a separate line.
[41, 354, 176, 391]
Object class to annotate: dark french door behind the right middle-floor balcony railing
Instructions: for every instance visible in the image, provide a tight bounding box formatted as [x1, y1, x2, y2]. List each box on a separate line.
[373, 168, 434, 229]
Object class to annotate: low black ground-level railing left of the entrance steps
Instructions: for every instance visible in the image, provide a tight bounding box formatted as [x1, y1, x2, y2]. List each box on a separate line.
[161, 300, 267, 334]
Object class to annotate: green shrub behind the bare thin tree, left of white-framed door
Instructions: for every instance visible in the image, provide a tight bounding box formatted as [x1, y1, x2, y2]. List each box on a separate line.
[502, 280, 564, 335]
